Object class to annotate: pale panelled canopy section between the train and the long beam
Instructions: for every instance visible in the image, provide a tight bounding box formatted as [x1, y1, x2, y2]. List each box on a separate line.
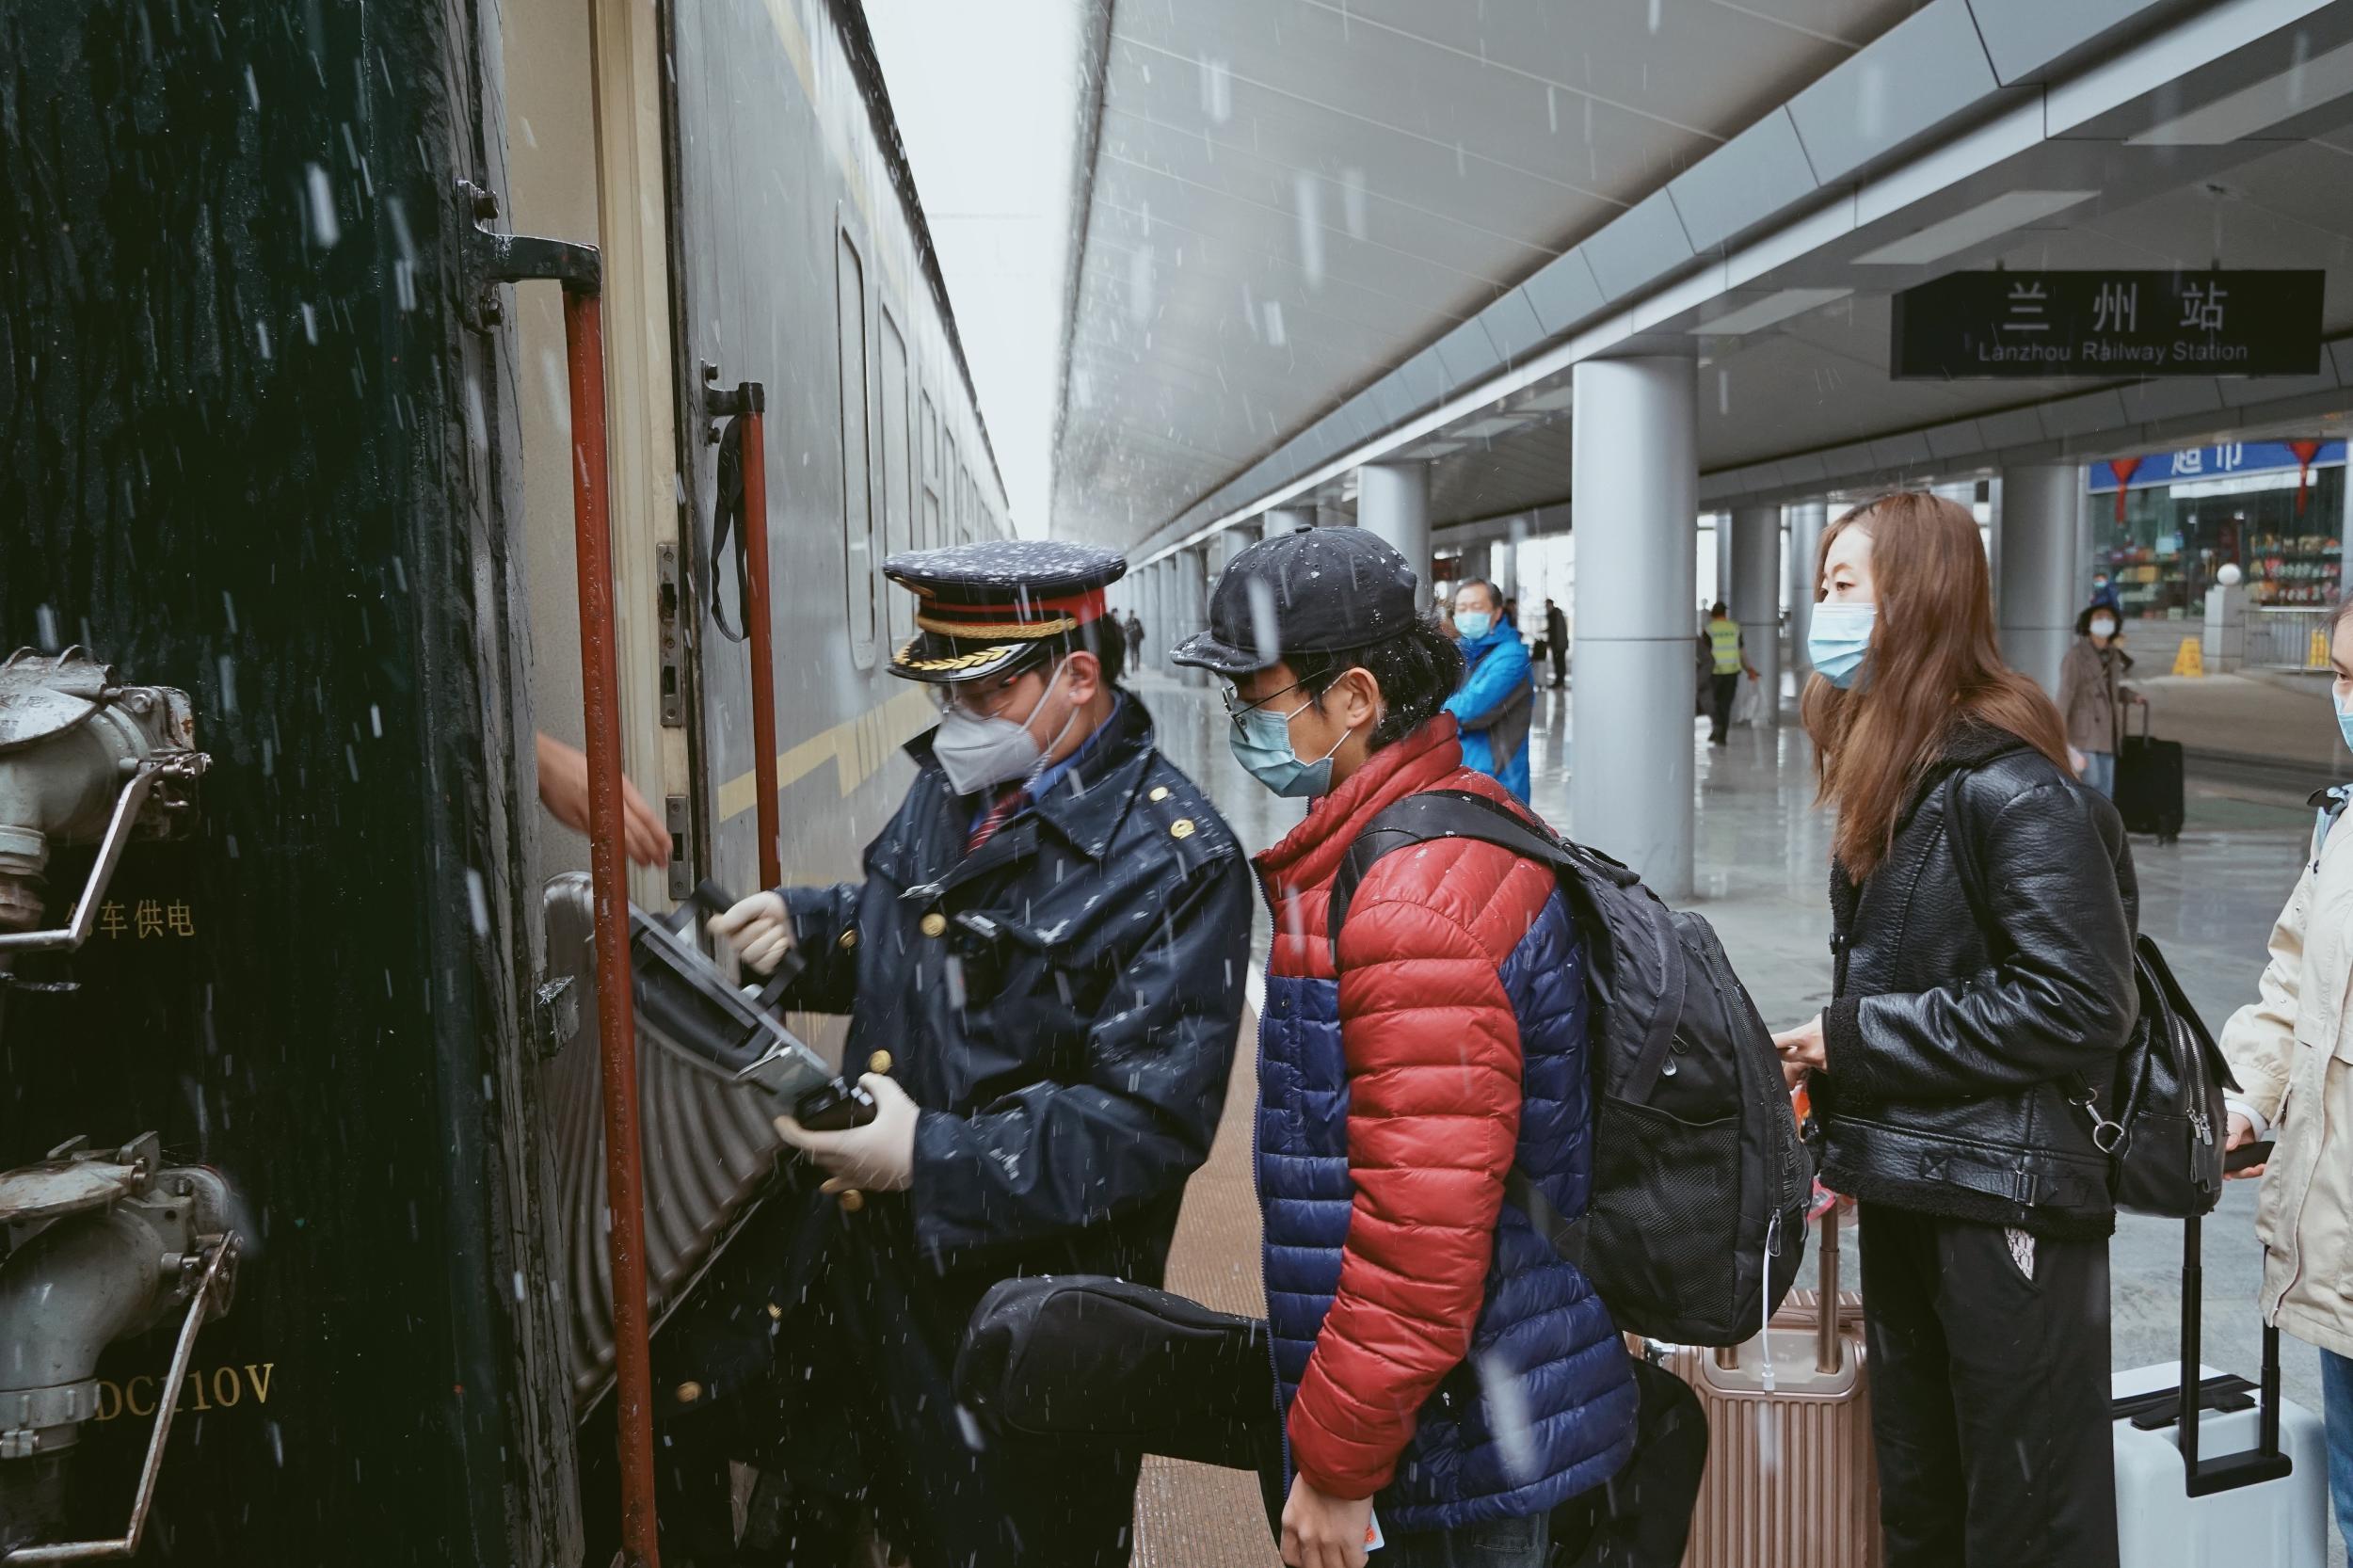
[1054, 0, 1915, 544]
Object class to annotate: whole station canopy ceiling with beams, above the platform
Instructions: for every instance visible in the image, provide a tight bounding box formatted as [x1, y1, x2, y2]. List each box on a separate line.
[1054, 0, 2353, 551]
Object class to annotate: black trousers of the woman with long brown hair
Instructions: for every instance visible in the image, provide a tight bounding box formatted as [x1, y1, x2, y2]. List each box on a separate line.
[1862, 1203, 2116, 1568]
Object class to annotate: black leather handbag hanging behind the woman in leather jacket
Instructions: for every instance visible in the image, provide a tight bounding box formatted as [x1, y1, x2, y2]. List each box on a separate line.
[2069, 937, 2238, 1220]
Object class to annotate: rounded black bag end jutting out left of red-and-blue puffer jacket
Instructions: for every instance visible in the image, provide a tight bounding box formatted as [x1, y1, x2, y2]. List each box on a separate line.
[955, 1273, 1283, 1469]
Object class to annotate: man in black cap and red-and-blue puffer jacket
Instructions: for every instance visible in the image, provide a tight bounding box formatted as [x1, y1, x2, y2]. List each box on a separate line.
[1176, 527, 1636, 1568]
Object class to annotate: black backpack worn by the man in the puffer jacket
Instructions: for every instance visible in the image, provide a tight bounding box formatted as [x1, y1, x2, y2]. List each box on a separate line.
[1327, 789, 1815, 1344]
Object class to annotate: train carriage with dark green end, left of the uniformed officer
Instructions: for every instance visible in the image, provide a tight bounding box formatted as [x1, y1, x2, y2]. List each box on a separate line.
[0, 0, 1005, 1563]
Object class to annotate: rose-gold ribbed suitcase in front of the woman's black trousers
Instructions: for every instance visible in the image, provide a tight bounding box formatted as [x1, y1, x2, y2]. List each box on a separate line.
[1669, 1206, 1882, 1568]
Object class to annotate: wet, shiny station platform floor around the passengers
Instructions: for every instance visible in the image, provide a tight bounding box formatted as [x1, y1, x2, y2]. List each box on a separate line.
[1132, 671, 2346, 1568]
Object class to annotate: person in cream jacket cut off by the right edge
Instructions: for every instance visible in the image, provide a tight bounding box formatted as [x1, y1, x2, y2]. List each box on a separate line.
[2221, 598, 2353, 1540]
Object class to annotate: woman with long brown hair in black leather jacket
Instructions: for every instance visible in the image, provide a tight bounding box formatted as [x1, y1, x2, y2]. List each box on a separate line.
[1774, 494, 2137, 1568]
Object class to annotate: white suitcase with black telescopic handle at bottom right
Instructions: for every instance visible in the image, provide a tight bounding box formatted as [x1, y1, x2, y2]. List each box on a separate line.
[2111, 1220, 2329, 1568]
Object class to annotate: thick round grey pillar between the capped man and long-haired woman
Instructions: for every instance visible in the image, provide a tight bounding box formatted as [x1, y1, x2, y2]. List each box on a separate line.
[1570, 356, 1699, 902]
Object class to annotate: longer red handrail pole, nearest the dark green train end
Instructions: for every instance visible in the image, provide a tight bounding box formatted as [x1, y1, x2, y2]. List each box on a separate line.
[565, 282, 662, 1568]
